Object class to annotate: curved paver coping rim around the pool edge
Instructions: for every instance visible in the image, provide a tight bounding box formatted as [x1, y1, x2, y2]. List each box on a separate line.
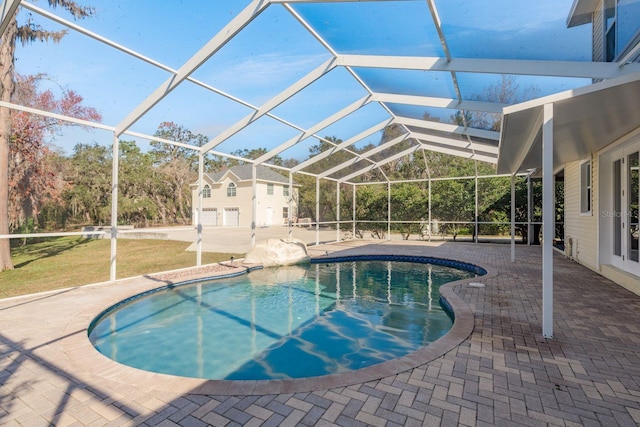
[62, 254, 497, 395]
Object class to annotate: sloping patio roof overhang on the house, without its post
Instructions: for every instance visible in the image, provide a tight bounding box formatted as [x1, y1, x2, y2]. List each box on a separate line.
[498, 73, 640, 174]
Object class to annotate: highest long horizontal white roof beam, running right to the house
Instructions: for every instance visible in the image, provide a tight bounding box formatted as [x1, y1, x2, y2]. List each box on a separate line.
[338, 55, 640, 79]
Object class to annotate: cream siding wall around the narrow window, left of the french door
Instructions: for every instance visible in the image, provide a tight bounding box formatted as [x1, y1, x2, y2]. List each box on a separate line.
[564, 156, 599, 271]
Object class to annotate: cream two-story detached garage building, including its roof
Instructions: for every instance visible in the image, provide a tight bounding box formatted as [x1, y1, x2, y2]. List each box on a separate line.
[191, 164, 298, 227]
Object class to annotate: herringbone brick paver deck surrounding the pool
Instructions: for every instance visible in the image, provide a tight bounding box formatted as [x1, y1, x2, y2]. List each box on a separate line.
[0, 242, 640, 426]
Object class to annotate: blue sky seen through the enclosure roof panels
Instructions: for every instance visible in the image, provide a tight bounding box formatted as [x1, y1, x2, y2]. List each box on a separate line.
[16, 0, 590, 159]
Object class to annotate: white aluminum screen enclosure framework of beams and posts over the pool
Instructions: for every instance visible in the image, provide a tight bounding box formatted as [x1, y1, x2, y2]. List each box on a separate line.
[0, 0, 640, 342]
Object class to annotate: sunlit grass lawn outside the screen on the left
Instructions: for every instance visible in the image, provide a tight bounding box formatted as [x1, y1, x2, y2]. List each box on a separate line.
[0, 236, 242, 298]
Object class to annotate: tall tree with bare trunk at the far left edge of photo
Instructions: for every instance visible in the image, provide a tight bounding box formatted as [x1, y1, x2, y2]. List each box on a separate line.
[0, 0, 94, 271]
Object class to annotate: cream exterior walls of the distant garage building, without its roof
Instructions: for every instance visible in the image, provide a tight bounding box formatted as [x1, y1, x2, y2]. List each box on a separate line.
[191, 177, 297, 227]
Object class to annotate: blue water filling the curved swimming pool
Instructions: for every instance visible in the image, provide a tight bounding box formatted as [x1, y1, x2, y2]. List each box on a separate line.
[89, 261, 476, 380]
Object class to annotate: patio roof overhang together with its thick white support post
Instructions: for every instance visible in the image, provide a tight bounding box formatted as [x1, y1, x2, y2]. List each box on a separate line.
[498, 73, 640, 337]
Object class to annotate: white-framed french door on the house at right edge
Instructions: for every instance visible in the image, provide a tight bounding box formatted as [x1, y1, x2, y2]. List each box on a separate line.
[612, 145, 640, 275]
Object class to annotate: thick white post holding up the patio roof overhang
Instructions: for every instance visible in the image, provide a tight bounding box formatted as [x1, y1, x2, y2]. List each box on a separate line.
[542, 104, 555, 338]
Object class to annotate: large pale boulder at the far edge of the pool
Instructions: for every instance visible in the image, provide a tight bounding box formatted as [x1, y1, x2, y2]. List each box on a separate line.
[244, 239, 310, 267]
